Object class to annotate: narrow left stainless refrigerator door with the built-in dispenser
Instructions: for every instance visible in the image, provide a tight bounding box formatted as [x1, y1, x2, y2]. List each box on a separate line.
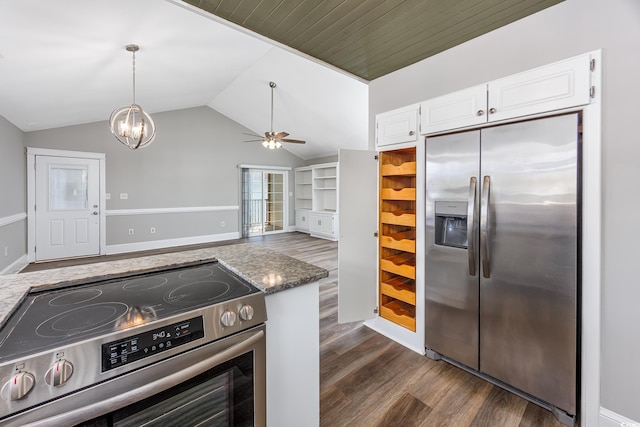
[425, 131, 480, 369]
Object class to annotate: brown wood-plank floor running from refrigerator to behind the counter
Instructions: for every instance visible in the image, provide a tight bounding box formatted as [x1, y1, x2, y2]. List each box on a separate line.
[23, 233, 562, 427]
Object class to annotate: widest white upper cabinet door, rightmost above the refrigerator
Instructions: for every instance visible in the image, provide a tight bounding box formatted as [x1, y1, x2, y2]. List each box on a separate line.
[488, 54, 591, 121]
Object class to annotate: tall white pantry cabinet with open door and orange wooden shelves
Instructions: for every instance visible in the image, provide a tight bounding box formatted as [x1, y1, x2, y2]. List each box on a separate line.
[338, 144, 425, 354]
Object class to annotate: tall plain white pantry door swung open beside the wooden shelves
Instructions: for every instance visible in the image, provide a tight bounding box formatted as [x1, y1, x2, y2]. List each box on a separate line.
[338, 150, 378, 323]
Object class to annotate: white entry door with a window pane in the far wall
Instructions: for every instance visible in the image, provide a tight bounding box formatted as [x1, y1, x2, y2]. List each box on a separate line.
[35, 156, 101, 261]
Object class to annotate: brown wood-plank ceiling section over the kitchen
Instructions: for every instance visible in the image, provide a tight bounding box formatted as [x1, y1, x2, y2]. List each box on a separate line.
[185, 0, 563, 80]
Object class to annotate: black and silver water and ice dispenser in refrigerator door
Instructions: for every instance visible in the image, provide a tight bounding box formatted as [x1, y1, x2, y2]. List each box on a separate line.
[435, 200, 468, 249]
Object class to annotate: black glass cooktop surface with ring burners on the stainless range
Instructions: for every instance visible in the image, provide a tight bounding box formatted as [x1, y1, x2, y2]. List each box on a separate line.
[0, 262, 260, 361]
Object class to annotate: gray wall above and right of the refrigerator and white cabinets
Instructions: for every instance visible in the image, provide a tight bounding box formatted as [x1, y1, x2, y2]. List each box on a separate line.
[369, 0, 640, 421]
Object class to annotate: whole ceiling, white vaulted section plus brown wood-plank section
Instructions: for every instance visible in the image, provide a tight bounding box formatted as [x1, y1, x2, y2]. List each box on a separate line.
[0, 0, 561, 159]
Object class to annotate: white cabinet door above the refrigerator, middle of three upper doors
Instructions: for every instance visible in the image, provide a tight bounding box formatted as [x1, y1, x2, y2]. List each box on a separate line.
[420, 84, 487, 134]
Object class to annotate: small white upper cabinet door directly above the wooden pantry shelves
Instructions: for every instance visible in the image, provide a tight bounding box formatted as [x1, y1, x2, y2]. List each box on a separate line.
[376, 105, 419, 147]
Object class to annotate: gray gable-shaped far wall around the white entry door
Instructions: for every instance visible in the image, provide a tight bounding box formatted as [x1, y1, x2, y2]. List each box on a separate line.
[24, 107, 304, 246]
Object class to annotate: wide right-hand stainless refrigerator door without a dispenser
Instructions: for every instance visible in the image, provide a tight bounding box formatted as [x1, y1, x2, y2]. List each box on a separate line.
[480, 114, 579, 414]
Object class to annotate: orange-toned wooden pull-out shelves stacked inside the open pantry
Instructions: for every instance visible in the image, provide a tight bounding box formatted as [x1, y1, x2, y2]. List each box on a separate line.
[379, 148, 416, 332]
